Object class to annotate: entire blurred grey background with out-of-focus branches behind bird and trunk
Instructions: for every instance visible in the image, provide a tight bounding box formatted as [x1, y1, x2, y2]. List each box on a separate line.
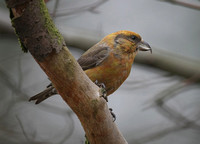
[0, 0, 200, 144]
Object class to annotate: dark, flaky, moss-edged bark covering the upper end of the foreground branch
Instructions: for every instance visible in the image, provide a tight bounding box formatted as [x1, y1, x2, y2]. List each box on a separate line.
[8, 0, 65, 61]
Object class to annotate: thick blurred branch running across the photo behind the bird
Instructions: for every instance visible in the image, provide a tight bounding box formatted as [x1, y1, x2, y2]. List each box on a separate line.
[0, 10, 200, 77]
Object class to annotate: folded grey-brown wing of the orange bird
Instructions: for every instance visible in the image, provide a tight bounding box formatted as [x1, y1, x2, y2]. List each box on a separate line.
[78, 44, 109, 70]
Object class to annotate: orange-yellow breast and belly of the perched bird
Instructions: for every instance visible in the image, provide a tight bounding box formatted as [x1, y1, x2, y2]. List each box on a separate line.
[85, 53, 134, 95]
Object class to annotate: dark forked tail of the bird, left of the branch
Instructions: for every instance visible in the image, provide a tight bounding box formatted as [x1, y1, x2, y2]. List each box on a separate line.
[29, 85, 57, 104]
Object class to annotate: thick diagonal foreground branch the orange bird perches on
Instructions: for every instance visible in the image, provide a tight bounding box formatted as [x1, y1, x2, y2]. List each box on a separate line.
[6, 0, 127, 144]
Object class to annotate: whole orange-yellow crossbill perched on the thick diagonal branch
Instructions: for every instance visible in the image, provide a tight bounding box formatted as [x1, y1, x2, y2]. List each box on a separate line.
[29, 30, 152, 104]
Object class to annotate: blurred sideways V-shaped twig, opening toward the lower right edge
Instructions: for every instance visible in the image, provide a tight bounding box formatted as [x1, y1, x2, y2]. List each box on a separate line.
[154, 74, 200, 130]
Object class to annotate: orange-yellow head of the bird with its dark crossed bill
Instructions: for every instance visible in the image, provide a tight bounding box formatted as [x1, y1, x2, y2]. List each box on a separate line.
[105, 30, 152, 54]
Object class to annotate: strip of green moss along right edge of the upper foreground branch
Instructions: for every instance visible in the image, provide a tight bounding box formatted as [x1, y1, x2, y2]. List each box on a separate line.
[40, 0, 63, 45]
